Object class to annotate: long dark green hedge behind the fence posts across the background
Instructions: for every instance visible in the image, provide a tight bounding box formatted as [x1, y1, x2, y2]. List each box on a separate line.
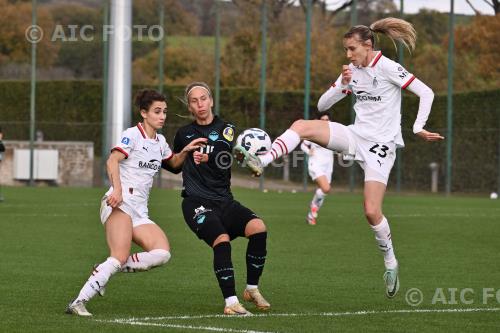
[0, 81, 500, 192]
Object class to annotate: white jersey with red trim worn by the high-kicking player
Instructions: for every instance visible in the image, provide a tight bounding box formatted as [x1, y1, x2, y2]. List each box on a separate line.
[318, 51, 415, 147]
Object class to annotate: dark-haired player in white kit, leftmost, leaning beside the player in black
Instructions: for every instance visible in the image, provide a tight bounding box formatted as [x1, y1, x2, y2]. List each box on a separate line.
[66, 90, 206, 316]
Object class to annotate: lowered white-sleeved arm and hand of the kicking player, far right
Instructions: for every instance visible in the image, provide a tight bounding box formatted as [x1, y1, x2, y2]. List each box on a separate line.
[407, 78, 444, 141]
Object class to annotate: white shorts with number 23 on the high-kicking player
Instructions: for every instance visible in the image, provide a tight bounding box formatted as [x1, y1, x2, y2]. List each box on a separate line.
[328, 122, 396, 185]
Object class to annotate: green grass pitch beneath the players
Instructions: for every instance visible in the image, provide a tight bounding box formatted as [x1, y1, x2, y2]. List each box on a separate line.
[0, 188, 500, 333]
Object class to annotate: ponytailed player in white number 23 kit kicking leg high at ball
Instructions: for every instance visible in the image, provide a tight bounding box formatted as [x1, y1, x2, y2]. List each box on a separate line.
[235, 17, 444, 298]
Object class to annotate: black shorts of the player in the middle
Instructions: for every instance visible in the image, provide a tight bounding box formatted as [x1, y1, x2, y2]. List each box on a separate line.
[182, 197, 259, 247]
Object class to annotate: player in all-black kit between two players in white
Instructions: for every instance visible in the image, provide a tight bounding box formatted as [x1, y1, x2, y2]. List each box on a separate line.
[166, 82, 271, 315]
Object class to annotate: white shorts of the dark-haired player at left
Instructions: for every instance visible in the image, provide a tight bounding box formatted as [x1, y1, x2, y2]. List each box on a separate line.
[100, 187, 155, 228]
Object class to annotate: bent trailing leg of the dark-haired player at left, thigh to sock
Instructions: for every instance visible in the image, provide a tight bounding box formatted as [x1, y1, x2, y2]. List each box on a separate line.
[122, 224, 171, 272]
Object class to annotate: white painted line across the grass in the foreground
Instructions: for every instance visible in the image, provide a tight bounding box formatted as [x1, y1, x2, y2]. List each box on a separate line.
[107, 308, 500, 323]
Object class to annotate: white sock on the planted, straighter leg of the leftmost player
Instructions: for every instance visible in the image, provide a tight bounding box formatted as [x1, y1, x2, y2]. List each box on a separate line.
[75, 257, 121, 302]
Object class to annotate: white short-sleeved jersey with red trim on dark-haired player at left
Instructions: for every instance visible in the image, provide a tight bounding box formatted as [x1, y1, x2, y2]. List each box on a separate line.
[111, 123, 174, 192]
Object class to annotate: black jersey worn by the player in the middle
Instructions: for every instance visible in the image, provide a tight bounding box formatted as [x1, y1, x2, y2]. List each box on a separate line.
[174, 116, 234, 200]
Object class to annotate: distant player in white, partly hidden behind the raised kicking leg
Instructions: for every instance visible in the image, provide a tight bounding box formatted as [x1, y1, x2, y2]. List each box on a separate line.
[300, 111, 333, 225]
